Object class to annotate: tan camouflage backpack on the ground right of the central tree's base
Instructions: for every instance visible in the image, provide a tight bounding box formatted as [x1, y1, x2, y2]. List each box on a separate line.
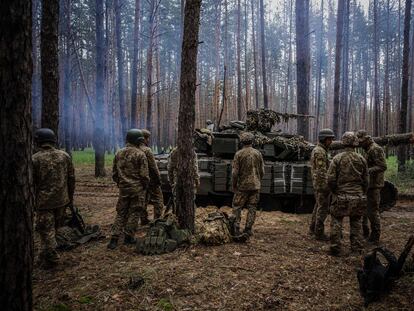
[200, 211, 232, 245]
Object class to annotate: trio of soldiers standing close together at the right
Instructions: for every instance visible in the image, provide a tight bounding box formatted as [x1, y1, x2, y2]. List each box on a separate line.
[309, 129, 387, 256]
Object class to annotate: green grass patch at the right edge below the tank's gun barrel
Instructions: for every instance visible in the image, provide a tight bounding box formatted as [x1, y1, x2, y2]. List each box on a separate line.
[385, 156, 414, 193]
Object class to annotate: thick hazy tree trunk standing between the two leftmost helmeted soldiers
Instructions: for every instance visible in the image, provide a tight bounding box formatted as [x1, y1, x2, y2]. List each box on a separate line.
[93, 0, 106, 177]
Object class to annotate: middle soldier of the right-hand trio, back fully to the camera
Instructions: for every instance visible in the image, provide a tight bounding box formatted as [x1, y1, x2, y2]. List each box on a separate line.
[328, 132, 368, 256]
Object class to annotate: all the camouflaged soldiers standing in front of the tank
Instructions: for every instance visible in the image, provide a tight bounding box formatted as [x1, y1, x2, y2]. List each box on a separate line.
[33, 124, 386, 268]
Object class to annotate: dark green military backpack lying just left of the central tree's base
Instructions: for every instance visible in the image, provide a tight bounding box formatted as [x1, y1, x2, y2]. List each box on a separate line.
[137, 217, 191, 255]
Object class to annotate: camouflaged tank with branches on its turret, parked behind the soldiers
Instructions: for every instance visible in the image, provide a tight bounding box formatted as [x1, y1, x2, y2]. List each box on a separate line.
[156, 109, 413, 213]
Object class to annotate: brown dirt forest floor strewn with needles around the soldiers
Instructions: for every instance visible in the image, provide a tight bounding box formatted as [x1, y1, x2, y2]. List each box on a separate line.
[34, 168, 414, 311]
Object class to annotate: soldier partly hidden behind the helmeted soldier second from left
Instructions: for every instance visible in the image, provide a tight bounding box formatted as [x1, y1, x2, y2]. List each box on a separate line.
[140, 130, 164, 220]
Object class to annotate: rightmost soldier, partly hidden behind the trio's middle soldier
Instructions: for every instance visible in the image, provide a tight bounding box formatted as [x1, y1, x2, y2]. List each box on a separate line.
[357, 130, 387, 244]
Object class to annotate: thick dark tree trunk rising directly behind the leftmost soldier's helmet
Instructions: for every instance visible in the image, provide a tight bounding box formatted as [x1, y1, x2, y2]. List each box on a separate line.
[40, 0, 59, 135]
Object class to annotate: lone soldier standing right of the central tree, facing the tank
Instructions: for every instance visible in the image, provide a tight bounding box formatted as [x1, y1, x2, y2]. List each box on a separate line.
[232, 132, 264, 236]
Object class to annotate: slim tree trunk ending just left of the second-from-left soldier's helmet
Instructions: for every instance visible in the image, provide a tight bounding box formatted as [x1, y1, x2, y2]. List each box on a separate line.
[114, 0, 128, 138]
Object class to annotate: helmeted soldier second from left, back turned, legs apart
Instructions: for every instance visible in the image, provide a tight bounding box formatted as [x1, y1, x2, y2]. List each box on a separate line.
[108, 129, 150, 249]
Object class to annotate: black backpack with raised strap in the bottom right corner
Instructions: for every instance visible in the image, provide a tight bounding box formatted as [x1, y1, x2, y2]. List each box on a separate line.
[357, 236, 414, 306]
